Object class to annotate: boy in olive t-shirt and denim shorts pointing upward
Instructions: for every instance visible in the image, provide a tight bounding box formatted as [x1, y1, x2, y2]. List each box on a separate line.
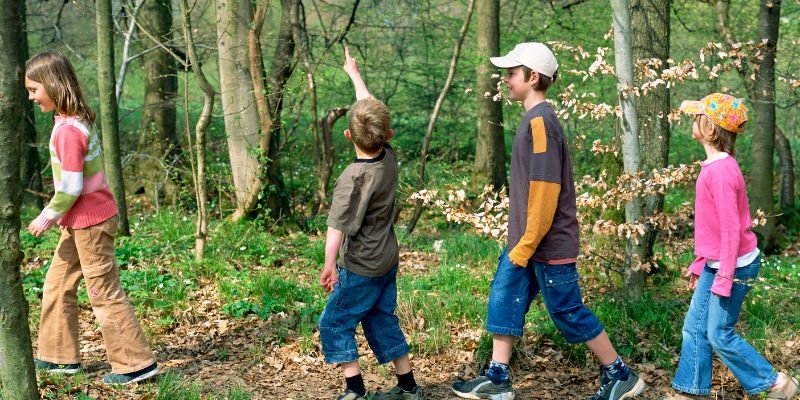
[319, 48, 423, 400]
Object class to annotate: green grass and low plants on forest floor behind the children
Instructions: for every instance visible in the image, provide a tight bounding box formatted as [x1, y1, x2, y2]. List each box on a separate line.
[17, 206, 800, 399]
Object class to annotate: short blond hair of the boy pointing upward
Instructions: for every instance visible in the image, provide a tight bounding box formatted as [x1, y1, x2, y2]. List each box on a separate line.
[349, 98, 392, 152]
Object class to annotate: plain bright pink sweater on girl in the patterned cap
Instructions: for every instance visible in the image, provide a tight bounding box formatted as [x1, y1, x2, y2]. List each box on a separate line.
[689, 156, 757, 297]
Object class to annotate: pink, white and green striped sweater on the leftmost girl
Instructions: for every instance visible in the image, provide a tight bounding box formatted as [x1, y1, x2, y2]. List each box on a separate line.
[34, 116, 117, 229]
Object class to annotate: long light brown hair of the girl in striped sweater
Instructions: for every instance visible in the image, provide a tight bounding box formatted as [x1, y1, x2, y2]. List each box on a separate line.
[25, 51, 95, 125]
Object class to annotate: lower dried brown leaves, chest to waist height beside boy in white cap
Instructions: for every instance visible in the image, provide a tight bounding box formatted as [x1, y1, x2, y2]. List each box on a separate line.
[408, 163, 766, 271]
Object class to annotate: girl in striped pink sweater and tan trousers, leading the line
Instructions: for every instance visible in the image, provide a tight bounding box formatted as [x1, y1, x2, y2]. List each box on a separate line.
[25, 51, 158, 385]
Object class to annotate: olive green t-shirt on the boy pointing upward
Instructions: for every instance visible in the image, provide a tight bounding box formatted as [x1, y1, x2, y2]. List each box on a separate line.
[328, 144, 400, 277]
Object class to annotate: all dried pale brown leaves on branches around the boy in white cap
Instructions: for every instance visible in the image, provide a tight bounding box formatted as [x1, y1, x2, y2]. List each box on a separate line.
[424, 35, 800, 282]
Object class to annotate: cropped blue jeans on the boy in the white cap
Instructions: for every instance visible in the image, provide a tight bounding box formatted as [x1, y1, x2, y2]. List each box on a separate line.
[486, 249, 603, 344]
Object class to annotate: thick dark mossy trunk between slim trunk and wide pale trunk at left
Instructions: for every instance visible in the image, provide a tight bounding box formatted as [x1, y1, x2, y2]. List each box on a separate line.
[138, 0, 181, 203]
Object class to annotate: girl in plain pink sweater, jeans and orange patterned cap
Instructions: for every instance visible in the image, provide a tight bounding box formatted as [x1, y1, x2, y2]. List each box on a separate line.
[672, 93, 798, 399]
